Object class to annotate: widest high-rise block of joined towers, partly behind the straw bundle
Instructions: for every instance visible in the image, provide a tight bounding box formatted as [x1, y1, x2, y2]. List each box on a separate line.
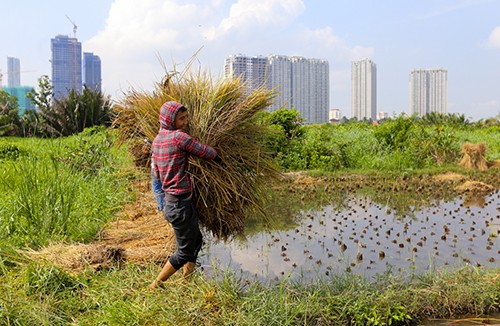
[224, 55, 329, 123]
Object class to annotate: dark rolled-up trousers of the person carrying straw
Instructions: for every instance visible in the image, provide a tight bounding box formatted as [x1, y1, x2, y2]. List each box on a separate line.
[163, 199, 203, 269]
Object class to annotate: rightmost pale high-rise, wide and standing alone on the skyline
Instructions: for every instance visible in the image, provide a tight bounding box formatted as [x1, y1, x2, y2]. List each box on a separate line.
[410, 68, 448, 117]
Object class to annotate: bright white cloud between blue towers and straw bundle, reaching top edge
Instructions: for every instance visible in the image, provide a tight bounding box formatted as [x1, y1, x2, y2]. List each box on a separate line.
[84, 0, 220, 95]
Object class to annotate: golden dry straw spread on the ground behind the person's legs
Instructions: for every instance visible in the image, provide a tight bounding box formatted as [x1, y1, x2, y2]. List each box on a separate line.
[28, 180, 175, 272]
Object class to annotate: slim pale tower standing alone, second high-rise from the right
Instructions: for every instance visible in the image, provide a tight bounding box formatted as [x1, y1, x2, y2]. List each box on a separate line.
[351, 59, 377, 120]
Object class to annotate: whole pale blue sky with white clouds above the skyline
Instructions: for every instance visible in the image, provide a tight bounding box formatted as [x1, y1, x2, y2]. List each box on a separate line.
[0, 0, 500, 120]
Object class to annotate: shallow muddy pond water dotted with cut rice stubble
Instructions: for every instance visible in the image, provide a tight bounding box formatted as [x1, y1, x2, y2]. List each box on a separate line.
[201, 190, 500, 282]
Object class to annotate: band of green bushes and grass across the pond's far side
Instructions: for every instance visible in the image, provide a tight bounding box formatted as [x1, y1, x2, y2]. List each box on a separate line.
[265, 115, 500, 172]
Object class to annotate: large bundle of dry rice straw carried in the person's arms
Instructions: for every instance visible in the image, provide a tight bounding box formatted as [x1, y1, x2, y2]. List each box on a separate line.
[114, 65, 280, 240]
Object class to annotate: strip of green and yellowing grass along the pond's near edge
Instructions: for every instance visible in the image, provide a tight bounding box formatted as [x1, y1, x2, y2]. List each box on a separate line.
[0, 262, 500, 325]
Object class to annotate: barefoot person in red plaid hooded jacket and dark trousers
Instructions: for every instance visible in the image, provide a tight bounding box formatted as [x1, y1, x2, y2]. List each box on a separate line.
[149, 101, 220, 289]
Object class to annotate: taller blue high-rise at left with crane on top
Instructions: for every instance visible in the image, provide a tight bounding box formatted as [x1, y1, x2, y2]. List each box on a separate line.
[50, 35, 82, 98]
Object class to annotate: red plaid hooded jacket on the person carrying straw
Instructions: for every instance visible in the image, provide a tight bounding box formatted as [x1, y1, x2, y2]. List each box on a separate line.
[151, 101, 217, 195]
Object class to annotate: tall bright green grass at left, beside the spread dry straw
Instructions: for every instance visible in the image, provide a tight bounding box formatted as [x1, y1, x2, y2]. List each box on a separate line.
[0, 129, 131, 248]
